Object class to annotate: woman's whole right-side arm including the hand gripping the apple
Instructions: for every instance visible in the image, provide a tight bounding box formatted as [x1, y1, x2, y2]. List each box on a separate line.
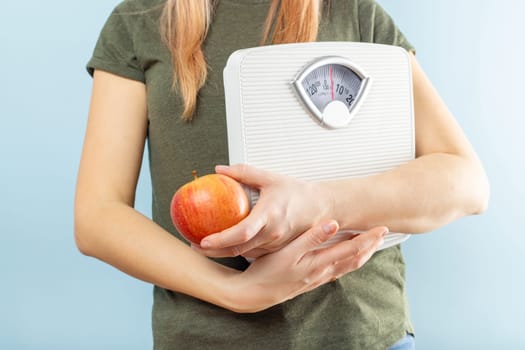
[196, 54, 489, 257]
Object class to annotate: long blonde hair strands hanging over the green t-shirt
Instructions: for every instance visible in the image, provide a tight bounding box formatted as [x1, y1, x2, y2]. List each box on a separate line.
[161, 0, 322, 121]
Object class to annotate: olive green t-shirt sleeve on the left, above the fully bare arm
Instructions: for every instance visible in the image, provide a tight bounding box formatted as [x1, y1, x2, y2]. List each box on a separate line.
[86, 6, 145, 82]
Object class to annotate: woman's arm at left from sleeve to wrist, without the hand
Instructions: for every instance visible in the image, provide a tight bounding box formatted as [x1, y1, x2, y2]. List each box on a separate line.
[75, 71, 234, 307]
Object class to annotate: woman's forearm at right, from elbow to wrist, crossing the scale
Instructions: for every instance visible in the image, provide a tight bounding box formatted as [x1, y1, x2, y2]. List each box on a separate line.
[322, 153, 489, 233]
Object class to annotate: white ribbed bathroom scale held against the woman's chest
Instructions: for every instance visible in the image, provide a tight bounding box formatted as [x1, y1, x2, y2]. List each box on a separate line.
[224, 42, 415, 249]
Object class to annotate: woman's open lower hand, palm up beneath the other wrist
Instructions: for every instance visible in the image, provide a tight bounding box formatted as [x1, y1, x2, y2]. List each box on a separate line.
[223, 221, 388, 313]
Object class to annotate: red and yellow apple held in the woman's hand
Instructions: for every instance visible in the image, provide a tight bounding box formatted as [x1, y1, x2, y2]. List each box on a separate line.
[170, 171, 250, 244]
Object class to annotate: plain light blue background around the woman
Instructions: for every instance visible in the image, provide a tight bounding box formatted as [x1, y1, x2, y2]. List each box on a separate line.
[0, 0, 525, 350]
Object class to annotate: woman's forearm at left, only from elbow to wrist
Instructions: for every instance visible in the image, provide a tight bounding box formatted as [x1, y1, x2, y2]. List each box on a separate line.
[75, 202, 239, 309]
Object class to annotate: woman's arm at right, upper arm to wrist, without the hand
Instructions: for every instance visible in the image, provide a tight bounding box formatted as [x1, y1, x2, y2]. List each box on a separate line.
[323, 55, 489, 233]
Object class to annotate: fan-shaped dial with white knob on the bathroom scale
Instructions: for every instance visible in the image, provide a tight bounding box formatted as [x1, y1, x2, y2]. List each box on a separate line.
[292, 56, 371, 128]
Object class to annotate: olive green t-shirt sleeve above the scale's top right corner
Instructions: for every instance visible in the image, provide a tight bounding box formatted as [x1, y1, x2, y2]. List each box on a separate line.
[359, 0, 416, 53]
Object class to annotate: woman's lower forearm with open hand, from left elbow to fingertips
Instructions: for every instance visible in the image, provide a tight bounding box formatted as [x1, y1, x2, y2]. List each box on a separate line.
[72, 203, 386, 313]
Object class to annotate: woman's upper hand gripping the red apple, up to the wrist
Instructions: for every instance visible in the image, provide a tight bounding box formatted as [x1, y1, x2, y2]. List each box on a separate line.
[195, 164, 331, 258]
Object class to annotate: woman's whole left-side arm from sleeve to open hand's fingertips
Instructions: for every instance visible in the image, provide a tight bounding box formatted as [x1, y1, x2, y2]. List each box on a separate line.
[75, 71, 386, 312]
